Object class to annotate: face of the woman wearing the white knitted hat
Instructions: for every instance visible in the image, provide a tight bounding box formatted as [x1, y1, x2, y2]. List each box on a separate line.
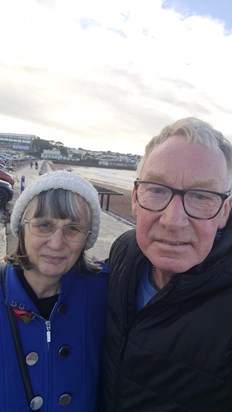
[24, 199, 87, 278]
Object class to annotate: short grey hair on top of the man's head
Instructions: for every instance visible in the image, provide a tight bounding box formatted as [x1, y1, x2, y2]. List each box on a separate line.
[137, 117, 232, 182]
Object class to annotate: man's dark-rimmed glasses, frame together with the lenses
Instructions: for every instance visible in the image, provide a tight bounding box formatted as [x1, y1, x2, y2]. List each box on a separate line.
[134, 180, 230, 219]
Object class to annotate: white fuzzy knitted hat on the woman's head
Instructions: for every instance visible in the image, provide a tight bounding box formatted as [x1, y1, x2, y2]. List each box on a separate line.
[11, 170, 101, 249]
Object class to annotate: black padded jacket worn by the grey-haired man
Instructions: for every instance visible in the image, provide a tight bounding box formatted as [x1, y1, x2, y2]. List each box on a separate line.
[105, 219, 232, 412]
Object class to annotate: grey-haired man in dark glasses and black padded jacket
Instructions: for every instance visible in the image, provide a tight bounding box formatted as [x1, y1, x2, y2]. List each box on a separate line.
[105, 118, 232, 412]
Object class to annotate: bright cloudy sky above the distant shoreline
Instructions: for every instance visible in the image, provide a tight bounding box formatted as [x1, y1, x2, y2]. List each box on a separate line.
[0, 0, 232, 155]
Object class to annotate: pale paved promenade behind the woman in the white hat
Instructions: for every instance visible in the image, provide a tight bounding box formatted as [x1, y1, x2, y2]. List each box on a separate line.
[0, 161, 134, 260]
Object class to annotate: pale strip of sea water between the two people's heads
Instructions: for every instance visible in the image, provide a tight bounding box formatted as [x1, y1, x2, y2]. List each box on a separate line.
[66, 166, 136, 190]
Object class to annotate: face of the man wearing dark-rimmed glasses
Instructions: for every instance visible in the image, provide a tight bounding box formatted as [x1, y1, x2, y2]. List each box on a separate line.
[132, 136, 230, 276]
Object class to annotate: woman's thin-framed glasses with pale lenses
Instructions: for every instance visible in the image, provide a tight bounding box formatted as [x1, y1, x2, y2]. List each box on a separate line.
[24, 218, 91, 243]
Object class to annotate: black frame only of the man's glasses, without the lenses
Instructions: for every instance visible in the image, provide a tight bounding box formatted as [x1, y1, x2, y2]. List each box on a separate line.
[134, 179, 231, 220]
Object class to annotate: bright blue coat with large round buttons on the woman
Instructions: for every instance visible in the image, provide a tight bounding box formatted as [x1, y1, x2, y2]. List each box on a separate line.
[0, 265, 108, 412]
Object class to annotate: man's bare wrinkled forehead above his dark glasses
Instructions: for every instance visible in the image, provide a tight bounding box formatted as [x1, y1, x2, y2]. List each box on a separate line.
[139, 136, 230, 191]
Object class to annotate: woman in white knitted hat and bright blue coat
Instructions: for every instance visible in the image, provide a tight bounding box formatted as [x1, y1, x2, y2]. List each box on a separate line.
[0, 171, 108, 412]
